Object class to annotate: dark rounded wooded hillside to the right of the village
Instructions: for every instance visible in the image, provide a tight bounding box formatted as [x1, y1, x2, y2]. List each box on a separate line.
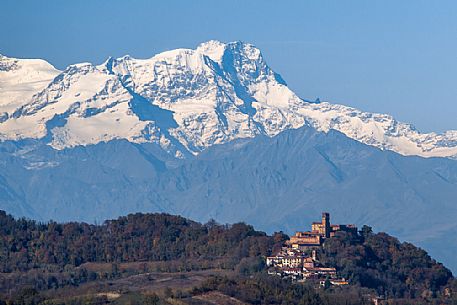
[319, 226, 453, 298]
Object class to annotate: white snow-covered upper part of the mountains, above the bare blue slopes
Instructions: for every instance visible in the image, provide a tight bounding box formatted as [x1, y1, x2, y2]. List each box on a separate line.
[0, 41, 457, 158]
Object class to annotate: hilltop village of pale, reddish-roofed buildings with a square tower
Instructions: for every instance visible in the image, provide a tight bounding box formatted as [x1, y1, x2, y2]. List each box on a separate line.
[266, 213, 357, 286]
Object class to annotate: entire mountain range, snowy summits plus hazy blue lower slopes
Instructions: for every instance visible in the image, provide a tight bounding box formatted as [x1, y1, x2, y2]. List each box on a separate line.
[0, 41, 457, 271]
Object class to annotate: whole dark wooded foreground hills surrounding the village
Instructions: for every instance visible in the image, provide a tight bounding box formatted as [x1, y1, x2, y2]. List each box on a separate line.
[0, 212, 457, 304]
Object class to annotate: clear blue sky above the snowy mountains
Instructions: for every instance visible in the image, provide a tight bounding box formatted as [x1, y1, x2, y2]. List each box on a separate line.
[0, 0, 457, 131]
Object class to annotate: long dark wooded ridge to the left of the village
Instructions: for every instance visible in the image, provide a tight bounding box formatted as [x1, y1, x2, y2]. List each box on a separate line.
[0, 211, 283, 272]
